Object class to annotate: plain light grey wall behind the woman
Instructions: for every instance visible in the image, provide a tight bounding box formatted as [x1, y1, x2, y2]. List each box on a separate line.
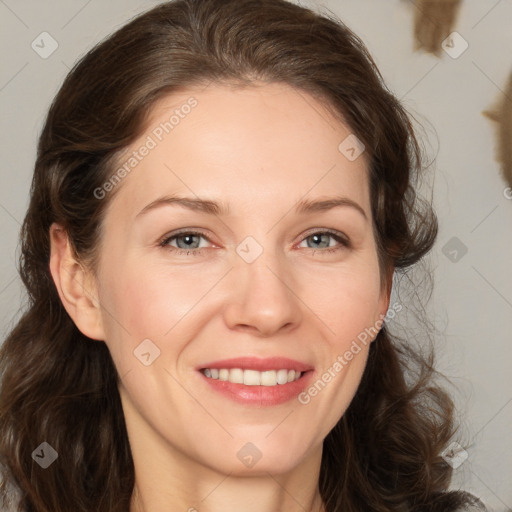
[0, 0, 512, 511]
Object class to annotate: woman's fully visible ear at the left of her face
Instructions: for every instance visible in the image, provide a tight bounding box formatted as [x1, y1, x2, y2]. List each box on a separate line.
[50, 223, 104, 340]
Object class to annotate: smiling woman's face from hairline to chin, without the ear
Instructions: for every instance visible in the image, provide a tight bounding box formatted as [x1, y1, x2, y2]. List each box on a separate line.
[92, 80, 388, 474]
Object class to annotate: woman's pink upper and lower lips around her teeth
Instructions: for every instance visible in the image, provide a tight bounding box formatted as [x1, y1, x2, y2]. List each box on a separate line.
[197, 357, 315, 407]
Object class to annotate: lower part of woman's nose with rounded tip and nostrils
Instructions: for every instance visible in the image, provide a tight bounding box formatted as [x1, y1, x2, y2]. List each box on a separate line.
[224, 251, 302, 337]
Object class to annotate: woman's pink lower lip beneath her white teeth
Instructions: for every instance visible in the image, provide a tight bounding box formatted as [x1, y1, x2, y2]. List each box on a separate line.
[199, 371, 313, 407]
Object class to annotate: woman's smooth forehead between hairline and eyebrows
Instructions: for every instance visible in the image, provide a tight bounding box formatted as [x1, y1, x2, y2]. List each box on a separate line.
[105, 83, 369, 220]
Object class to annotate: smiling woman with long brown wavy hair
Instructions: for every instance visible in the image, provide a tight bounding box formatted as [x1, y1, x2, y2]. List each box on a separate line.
[0, 0, 488, 512]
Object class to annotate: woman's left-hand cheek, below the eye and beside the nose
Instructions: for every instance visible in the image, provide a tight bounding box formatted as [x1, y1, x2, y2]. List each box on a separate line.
[95, 258, 218, 371]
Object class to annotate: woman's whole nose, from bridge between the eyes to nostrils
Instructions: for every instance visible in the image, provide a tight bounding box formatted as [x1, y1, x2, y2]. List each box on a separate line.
[226, 237, 300, 336]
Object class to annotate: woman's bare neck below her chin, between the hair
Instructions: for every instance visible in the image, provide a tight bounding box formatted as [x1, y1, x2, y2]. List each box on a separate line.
[130, 428, 325, 512]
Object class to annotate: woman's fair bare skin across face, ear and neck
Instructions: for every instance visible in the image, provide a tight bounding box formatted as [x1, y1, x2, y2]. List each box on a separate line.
[50, 84, 389, 512]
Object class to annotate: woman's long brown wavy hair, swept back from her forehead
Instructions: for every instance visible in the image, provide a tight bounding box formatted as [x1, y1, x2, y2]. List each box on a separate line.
[0, 0, 476, 512]
